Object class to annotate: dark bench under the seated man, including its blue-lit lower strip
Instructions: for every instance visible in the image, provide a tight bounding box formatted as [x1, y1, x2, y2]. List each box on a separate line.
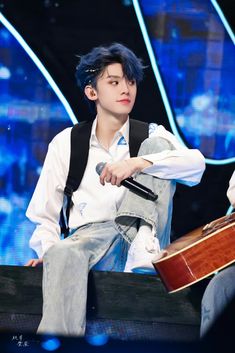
[0, 266, 206, 342]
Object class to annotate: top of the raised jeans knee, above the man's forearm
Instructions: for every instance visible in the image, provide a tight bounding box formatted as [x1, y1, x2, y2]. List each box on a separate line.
[138, 136, 173, 155]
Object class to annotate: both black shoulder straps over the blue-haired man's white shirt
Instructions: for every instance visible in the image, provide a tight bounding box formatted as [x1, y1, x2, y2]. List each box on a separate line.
[60, 119, 149, 238]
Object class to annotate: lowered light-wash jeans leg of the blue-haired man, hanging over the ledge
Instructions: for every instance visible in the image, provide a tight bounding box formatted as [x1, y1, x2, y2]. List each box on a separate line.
[38, 221, 128, 335]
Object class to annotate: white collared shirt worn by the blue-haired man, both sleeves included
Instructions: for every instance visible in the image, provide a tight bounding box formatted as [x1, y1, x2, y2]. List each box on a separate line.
[26, 119, 205, 258]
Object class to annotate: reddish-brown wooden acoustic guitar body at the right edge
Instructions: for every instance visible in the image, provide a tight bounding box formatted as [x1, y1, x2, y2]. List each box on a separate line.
[153, 212, 235, 293]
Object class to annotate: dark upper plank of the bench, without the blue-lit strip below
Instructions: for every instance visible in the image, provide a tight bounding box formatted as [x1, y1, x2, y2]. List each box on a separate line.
[0, 266, 206, 325]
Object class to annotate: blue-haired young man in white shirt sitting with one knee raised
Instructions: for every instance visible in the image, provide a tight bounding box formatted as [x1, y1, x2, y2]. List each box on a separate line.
[27, 43, 205, 335]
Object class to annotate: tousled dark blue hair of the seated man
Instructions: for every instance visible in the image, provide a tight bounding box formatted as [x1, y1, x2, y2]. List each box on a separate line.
[75, 43, 145, 92]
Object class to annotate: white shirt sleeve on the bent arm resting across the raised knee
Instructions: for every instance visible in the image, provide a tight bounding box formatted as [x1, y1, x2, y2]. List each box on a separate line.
[142, 124, 205, 186]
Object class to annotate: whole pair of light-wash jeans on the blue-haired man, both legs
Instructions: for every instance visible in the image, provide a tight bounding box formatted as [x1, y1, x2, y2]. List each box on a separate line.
[37, 138, 175, 336]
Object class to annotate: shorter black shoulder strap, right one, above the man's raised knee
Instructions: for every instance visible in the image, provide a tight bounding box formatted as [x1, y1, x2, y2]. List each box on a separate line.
[129, 119, 149, 157]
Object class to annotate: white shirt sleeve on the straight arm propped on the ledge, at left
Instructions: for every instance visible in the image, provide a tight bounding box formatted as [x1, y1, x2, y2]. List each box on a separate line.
[26, 128, 70, 258]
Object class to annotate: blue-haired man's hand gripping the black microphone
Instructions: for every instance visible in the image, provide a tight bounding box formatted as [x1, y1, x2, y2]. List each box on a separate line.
[100, 157, 152, 186]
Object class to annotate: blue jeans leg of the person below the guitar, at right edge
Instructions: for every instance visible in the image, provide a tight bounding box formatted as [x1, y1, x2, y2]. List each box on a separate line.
[200, 265, 235, 337]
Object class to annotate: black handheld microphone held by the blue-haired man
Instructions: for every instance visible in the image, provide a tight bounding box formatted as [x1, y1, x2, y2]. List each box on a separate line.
[95, 162, 158, 201]
